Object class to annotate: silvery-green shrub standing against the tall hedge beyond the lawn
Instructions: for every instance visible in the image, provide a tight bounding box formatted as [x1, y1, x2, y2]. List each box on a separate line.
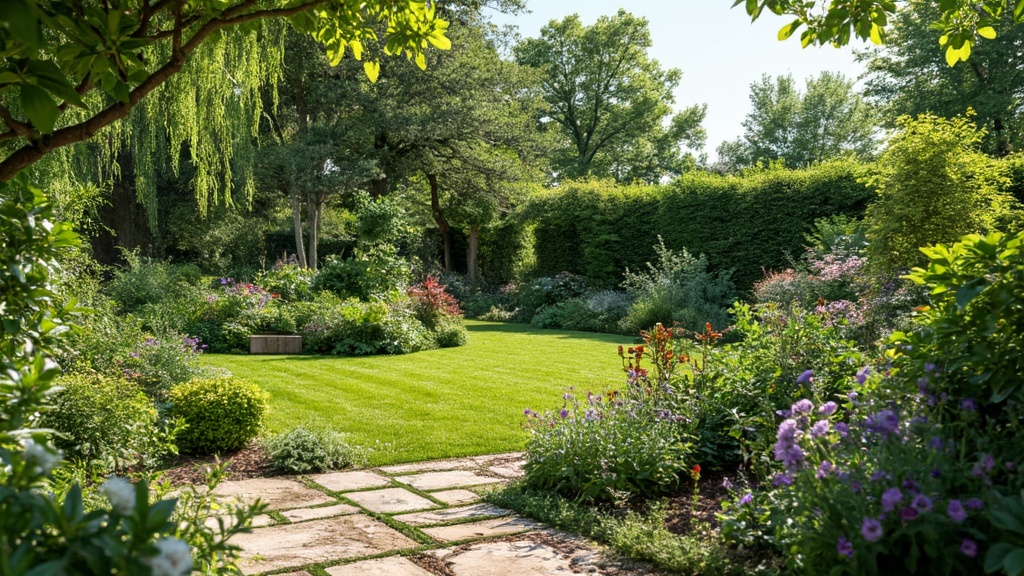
[623, 240, 735, 333]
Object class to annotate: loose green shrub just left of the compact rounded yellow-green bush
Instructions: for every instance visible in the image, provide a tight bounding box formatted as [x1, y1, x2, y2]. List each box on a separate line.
[40, 373, 174, 472]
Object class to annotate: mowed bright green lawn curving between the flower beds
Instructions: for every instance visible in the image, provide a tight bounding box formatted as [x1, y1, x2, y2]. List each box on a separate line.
[205, 321, 631, 465]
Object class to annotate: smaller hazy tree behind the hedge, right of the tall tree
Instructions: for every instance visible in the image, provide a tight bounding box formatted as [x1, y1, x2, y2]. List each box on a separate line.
[718, 72, 878, 169]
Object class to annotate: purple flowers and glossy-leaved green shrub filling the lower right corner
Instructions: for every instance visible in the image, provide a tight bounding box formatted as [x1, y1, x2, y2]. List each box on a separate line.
[726, 229, 1024, 574]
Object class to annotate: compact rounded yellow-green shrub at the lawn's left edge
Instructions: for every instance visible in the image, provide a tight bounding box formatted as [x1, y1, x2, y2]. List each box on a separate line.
[170, 378, 270, 454]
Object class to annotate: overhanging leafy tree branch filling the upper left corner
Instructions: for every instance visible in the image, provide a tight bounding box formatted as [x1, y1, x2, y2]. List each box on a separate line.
[0, 0, 450, 181]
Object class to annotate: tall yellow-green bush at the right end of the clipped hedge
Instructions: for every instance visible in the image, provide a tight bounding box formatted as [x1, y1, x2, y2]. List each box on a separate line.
[864, 115, 1013, 273]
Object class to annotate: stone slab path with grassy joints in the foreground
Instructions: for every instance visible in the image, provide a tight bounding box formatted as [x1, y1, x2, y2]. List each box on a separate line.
[207, 453, 651, 576]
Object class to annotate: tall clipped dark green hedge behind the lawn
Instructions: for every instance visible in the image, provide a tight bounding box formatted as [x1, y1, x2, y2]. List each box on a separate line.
[524, 162, 874, 289]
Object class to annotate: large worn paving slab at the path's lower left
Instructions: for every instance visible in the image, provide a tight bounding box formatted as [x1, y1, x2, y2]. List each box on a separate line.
[231, 515, 418, 574]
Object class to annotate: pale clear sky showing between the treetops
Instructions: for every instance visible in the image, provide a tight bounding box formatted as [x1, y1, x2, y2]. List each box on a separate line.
[483, 0, 863, 159]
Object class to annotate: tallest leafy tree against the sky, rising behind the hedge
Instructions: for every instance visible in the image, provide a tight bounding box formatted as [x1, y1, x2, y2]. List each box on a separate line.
[515, 10, 707, 181]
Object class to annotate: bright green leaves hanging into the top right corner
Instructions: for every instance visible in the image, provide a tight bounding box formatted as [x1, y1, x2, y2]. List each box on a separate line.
[732, 0, 1024, 66]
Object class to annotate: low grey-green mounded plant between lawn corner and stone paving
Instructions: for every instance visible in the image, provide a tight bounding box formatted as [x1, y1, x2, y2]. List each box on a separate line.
[266, 425, 361, 474]
